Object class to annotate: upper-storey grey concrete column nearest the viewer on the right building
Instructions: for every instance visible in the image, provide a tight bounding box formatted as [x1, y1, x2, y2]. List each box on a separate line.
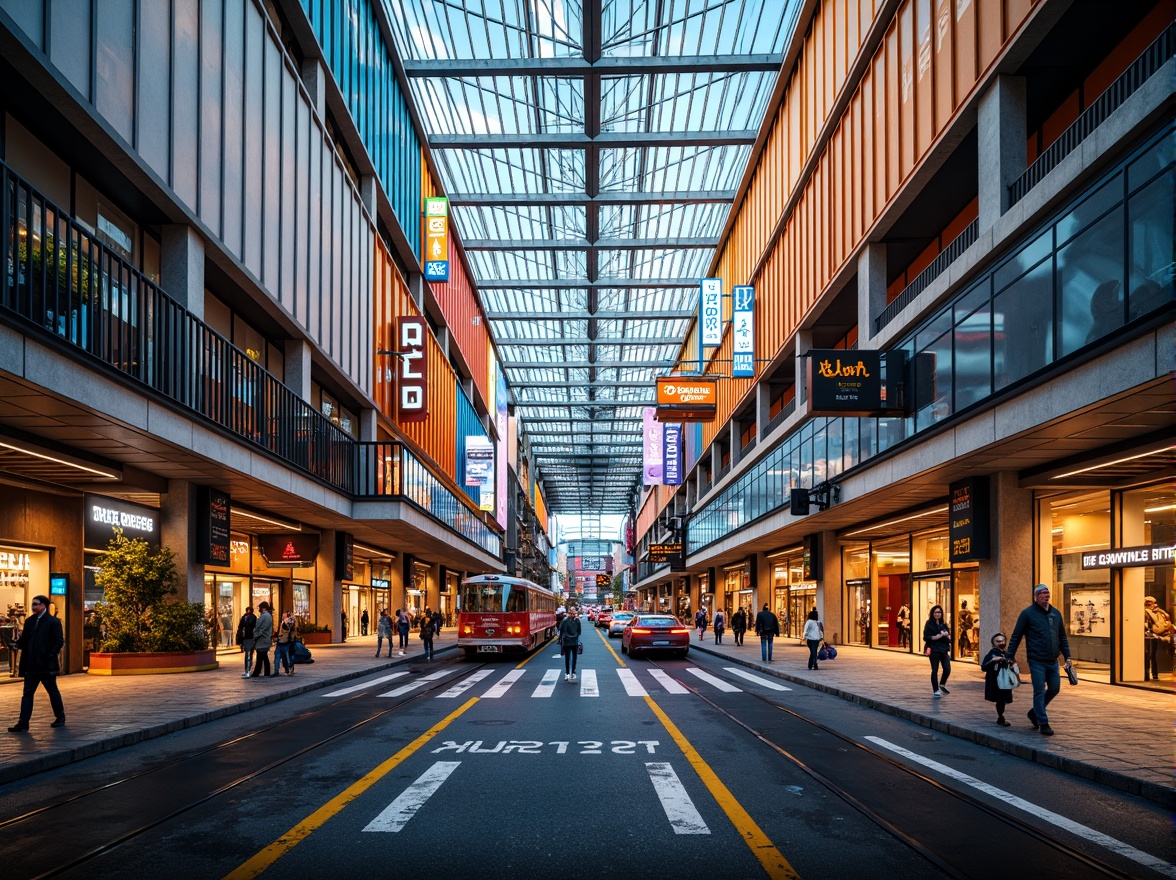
[976, 74, 1028, 232]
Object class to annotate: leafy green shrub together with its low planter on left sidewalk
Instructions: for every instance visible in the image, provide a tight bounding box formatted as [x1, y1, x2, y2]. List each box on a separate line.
[89, 529, 219, 675]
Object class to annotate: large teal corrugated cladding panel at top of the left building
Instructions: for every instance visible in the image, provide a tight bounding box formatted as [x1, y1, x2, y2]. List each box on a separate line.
[300, 0, 421, 259]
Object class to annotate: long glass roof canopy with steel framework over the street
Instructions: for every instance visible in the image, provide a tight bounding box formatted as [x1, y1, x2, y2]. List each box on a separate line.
[382, 0, 801, 515]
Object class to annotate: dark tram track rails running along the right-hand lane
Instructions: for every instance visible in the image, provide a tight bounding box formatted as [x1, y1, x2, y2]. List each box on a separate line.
[648, 661, 1160, 880]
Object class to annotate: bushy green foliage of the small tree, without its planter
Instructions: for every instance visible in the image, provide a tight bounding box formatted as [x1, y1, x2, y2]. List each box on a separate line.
[94, 528, 208, 653]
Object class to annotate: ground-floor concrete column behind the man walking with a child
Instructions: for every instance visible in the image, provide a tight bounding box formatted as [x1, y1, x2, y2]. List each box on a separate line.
[978, 471, 1034, 644]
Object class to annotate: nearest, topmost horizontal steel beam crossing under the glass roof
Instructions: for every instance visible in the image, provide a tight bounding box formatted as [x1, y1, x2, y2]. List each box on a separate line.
[401, 52, 784, 78]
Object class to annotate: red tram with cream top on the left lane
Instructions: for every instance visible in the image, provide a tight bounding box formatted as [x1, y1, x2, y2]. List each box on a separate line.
[457, 574, 557, 656]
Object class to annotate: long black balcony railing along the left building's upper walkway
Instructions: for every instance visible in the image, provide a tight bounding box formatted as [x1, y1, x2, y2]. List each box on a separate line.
[0, 162, 501, 555]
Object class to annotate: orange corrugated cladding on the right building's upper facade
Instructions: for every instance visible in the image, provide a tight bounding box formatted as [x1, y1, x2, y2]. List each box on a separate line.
[684, 0, 1035, 432]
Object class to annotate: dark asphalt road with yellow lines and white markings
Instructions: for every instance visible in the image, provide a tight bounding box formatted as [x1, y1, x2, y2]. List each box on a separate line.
[0, 631, 1176, 880]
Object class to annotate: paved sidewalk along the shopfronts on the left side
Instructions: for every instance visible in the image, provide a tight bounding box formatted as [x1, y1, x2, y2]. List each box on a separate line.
[0, 628, 457, 784]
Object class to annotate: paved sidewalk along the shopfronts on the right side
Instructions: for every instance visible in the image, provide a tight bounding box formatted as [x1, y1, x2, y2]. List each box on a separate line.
[690, 631, 1176, 806]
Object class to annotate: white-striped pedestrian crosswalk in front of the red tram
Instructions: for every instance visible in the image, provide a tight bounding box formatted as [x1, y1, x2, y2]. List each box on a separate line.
[323, 666, 791, 700]
